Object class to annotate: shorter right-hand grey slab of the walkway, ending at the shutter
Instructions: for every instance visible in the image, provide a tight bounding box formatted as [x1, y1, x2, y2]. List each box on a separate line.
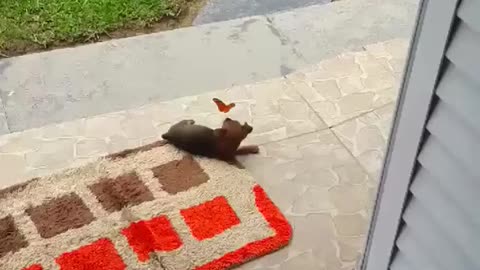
[268, 0, 419, 64]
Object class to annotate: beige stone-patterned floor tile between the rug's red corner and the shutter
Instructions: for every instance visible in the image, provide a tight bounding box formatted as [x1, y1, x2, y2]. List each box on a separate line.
[240, 130, 371, 270]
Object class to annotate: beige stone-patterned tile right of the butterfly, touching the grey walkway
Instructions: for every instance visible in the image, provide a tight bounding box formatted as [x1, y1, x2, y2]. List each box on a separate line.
[287, 39, 408, 127]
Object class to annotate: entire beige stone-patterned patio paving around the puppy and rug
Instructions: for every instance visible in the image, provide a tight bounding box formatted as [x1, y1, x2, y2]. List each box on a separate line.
[0, 40, 407, 270]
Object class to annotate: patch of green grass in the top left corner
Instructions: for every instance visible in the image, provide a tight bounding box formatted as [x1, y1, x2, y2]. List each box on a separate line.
[0, 0, 186, 52]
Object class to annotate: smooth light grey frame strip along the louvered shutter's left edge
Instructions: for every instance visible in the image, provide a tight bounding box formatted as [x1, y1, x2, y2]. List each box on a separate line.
[359, 0, 460, 270]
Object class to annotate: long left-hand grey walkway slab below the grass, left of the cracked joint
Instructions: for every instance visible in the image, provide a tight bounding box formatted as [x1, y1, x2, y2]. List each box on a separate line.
[0, 17, 305, 132]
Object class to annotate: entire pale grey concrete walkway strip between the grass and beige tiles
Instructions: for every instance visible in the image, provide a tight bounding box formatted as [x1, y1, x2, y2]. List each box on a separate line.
[0, 0, 418, 134]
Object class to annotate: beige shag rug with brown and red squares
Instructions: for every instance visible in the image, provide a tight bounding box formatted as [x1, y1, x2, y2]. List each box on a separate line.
[0, 142, 292, 270]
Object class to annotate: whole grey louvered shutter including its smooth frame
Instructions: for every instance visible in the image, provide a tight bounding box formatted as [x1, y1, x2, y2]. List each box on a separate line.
[362, 0, 480, 270]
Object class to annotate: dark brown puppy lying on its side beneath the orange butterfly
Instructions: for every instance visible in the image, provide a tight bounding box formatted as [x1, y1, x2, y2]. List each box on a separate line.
[162, 118, 259, 162]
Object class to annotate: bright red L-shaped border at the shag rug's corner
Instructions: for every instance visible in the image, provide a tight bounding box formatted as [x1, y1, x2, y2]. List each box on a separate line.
[195, 185, 292, 270]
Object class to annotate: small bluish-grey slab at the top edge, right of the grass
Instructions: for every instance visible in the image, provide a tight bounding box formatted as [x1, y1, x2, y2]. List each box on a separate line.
[193, 0, 331, 25]
